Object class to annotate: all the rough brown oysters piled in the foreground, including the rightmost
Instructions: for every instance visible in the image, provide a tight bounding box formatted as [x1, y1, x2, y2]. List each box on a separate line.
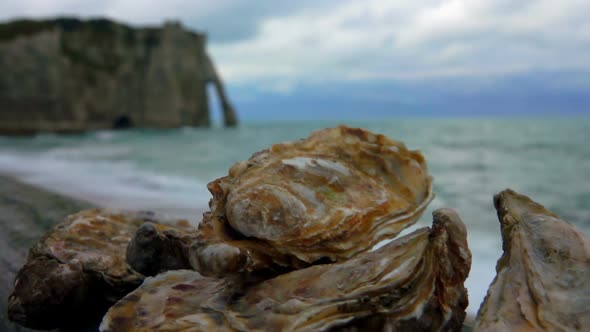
[9, 126, 590, 331]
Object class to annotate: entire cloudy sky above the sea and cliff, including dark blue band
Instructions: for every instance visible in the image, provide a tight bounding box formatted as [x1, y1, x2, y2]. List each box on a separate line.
[0, 0, 590, 119]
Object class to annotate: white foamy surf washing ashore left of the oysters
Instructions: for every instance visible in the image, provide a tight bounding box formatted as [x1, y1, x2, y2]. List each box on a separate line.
[0, 151, 210, 223]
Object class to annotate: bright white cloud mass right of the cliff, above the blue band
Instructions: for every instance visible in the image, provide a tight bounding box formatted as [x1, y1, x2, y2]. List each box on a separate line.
[206, 0, 590, 91]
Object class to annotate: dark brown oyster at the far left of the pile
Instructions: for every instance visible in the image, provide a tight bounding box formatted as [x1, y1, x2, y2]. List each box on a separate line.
[8, 209, 192, 329]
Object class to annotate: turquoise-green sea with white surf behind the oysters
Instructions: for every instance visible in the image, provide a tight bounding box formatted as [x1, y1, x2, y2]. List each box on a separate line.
[0, 117, 590, 314]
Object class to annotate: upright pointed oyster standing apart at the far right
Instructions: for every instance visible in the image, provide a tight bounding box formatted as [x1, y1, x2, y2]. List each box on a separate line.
[475, 189, 590, 331]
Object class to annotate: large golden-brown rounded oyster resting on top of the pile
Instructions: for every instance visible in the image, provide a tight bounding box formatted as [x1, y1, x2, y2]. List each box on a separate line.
[191, 126, 433, 275]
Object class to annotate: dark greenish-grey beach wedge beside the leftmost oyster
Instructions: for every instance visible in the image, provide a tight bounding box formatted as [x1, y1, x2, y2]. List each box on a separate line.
[0, 176, 91, 332]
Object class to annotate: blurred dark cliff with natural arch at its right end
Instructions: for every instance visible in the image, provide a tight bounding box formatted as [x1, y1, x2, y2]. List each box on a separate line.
[0, 19, 237, 134]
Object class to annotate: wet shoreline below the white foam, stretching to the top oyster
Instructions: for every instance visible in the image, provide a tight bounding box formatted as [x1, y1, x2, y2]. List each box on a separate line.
[0, 172, 206, 332]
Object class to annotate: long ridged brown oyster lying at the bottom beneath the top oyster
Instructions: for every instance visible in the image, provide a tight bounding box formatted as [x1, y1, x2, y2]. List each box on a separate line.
[100, 209, 471, 331]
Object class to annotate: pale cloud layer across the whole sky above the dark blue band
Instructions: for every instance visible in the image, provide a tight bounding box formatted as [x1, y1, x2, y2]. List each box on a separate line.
[0, 0, 590, 93]
